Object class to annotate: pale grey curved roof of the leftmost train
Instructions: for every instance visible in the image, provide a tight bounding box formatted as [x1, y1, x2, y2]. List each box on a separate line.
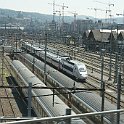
[12, 60, 75, 116]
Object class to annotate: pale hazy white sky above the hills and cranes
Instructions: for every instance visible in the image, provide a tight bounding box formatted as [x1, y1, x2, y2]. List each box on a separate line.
[0, 0, 124, 18]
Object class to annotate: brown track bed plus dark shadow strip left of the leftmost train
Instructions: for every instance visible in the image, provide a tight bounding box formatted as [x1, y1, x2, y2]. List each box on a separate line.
[0, 52, 35, 123]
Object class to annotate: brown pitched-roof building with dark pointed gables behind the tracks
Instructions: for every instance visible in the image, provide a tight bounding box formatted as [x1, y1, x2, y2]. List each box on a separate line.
[82, 30, 117, 52]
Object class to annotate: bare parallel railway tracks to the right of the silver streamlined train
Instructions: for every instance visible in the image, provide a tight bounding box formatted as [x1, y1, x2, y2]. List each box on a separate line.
[45, 44, 123, 102]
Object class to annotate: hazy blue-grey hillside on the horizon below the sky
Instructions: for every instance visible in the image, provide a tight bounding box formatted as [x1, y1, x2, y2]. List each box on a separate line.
[0, 9, 123, 26]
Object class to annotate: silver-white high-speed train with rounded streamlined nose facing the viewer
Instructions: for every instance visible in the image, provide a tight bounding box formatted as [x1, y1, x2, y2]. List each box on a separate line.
[22, 42, 88, 80]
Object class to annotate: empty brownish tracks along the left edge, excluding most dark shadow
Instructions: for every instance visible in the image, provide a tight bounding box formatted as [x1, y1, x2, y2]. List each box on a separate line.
[0, 55, 25, 122]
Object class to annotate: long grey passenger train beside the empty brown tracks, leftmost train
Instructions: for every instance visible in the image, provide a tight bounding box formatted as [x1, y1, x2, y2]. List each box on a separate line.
[10, 60, 86, 124]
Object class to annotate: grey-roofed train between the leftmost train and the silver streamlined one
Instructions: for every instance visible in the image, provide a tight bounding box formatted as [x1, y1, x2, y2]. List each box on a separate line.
[17, 54, 116, 124]
